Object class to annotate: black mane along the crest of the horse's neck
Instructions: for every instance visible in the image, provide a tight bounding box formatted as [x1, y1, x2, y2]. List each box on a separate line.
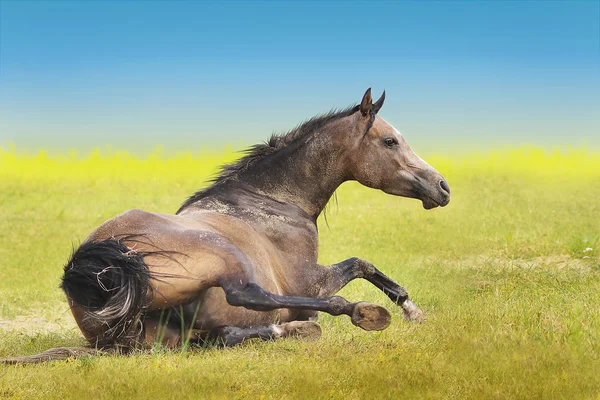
[177, 105, 359, 214]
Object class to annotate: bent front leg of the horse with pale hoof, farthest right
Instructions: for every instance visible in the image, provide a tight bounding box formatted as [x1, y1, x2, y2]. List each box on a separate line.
[319, 257, 425, 322]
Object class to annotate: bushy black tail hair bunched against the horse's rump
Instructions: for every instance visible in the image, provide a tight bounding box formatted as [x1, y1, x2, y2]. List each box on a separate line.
[60, 236, 152, 347]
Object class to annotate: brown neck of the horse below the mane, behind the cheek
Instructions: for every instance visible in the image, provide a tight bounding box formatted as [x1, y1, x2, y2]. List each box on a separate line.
[234, 128, 346, 220]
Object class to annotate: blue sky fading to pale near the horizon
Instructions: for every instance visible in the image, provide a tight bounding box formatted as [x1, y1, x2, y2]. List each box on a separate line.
[0, 0, 600, 152]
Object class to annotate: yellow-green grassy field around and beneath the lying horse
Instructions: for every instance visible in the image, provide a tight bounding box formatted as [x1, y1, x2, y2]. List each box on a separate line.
[0, 148, 600, 399]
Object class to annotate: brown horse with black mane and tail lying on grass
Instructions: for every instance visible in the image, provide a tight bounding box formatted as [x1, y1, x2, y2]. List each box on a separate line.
[4, 89, 450, 362]
